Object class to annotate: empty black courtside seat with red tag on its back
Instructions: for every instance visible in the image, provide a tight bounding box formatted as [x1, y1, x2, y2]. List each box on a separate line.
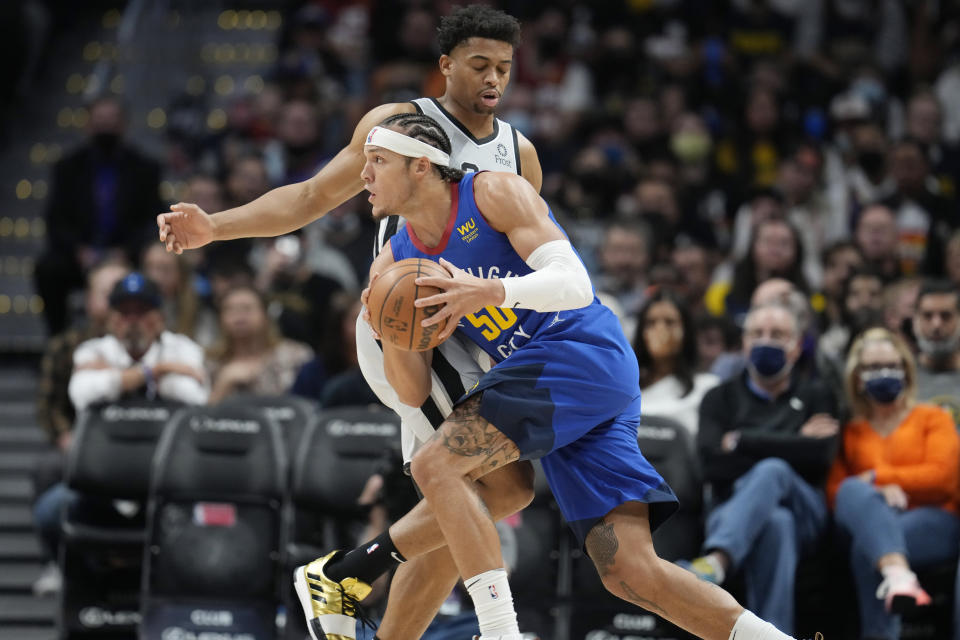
[141, 406, 287, 640]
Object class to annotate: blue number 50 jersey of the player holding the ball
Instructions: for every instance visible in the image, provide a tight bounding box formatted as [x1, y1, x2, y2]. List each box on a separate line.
[390, 173, 632, 362]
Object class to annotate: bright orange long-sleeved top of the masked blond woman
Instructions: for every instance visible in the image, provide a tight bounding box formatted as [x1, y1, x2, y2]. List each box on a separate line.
[827, 404, 960, 513]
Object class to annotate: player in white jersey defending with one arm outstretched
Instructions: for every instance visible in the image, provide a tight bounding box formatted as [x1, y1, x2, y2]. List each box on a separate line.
[157, 5, 543, 640]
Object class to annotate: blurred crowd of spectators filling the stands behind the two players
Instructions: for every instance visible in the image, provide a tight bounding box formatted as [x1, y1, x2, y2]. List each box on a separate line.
[22, 0, 960, 637]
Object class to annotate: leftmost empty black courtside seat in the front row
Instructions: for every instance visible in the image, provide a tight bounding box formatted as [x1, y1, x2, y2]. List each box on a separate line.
[60, 400, 182, 638]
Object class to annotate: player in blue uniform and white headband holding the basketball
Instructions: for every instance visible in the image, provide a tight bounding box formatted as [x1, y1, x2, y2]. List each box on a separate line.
[305, 116, 824, 640]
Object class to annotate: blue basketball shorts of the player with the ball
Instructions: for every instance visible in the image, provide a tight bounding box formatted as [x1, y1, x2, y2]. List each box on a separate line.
[461, 332, 679, 544]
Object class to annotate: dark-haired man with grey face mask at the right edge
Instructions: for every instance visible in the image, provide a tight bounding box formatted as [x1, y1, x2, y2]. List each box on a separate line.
[913, 280, 960, 424]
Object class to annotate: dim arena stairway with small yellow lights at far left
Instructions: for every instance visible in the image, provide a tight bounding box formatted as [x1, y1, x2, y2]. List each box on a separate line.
[0, 0, 283, 640]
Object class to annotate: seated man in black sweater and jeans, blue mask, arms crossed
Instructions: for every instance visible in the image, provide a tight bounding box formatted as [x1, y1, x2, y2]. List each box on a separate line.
[685, 304, 838, 633]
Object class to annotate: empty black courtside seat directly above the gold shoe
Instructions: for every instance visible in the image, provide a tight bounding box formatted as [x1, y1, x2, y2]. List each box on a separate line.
[285, 406, 409, 640]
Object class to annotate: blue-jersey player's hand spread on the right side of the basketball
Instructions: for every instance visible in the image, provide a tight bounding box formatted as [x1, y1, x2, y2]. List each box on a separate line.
[414, 258, 503, 341]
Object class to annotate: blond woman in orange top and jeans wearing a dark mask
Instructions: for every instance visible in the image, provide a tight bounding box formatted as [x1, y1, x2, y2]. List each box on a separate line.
[827, 329, 960, 640]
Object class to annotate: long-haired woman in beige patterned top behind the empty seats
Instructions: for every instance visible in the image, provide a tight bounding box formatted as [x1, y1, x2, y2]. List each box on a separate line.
[206, 286, 313, 404]
